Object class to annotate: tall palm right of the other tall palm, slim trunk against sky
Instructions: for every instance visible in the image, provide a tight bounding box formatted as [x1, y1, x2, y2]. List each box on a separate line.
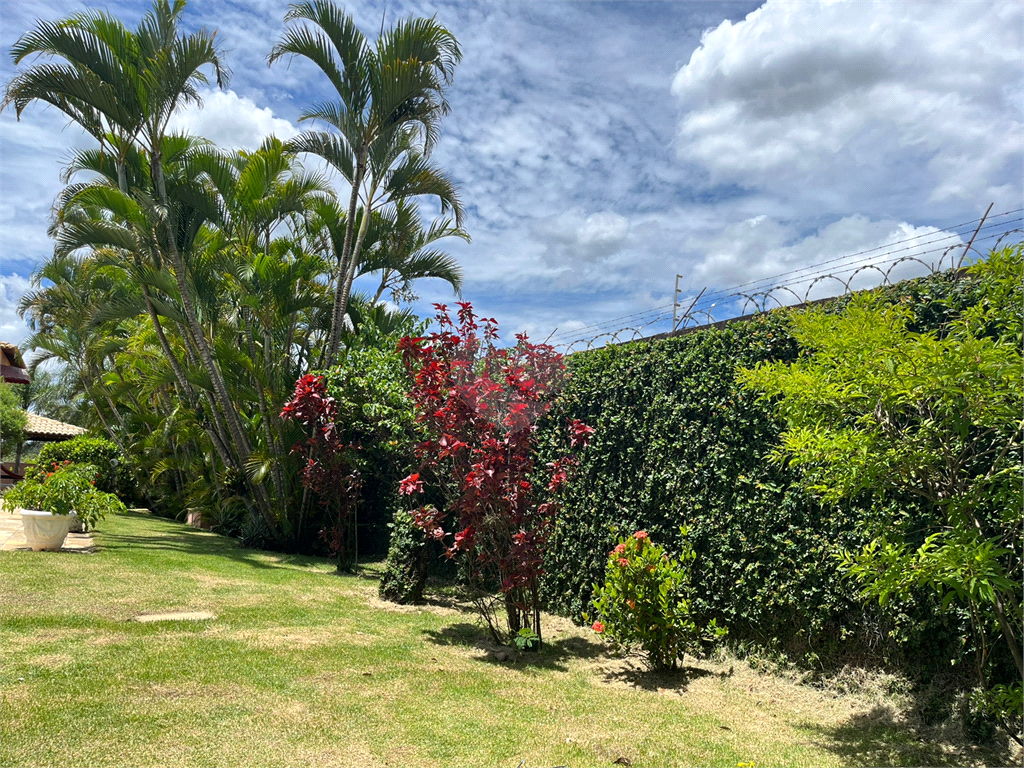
[268, 0, 463, 365]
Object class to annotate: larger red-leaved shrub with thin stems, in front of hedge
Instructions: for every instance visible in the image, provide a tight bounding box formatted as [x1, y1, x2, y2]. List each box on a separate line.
[399, 302, 594, 643]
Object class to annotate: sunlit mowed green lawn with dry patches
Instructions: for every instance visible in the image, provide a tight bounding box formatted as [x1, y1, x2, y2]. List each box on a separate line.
[0, 513, 1007, 768]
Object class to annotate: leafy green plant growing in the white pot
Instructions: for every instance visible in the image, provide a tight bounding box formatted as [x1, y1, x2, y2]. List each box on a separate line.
[4, 462, 127, 530]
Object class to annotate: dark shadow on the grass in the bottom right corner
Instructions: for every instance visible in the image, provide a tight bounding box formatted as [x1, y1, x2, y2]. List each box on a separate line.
[797, 706, 1012, 766]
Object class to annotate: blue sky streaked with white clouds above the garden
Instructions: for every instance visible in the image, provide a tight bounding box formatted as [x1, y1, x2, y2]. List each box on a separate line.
[0, 0, 1024, 352]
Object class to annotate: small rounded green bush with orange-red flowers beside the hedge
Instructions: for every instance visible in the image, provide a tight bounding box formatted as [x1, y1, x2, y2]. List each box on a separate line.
[591, 528, 725, 670]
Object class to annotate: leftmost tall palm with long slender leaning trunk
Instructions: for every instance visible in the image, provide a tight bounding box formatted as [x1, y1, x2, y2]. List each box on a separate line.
[4, 0, 303, 532]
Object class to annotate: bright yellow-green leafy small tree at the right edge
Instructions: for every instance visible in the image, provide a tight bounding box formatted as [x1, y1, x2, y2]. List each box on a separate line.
[739, 246, 1024, 740]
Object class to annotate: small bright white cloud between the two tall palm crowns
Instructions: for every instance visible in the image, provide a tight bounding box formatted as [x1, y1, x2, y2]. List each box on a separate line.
[170, 90, 300, 151]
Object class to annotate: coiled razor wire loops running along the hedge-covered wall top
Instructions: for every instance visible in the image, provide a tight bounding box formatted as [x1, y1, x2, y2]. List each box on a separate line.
[549, 219, 1024, 354]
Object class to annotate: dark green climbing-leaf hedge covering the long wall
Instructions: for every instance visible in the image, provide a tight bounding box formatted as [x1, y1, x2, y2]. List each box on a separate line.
[541, 274, 977, 670]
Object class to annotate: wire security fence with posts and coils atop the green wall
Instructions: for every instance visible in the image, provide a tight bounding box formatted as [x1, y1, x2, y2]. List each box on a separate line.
[547, 206, 1024, 354]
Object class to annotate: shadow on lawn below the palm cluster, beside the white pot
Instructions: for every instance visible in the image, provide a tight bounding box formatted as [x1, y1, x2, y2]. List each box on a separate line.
[102, 512, 325, 569]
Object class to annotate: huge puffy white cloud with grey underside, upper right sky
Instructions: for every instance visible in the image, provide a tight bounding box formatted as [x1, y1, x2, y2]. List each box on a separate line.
[672, 0, 1024, 215]
